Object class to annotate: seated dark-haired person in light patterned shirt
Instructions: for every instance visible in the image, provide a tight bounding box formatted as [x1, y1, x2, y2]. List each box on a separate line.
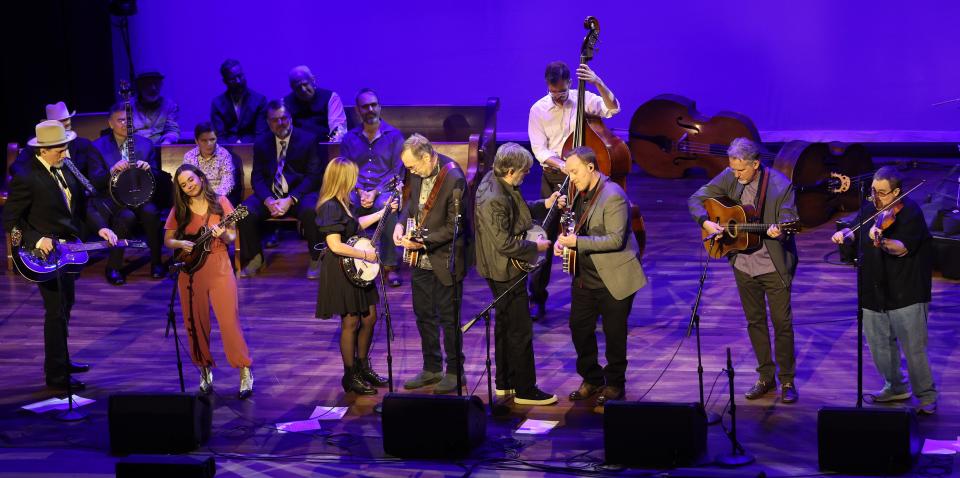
[183, 123, 243, 204]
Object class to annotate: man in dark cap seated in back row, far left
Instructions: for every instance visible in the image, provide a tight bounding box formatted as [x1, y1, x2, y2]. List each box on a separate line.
[133, 70, 180, 145]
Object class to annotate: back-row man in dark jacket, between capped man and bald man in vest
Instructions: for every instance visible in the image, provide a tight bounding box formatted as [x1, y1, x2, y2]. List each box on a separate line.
[210, 59, 268, 144]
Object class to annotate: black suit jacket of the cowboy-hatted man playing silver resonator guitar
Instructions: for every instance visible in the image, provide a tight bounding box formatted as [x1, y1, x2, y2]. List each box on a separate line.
[3, 157, 106, 248]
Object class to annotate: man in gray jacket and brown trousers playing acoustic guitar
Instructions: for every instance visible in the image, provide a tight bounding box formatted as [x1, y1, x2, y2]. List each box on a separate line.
[687, 138, 800, 403]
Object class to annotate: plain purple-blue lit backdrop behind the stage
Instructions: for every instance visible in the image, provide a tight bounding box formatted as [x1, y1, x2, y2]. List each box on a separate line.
[120, 0, 960, 140]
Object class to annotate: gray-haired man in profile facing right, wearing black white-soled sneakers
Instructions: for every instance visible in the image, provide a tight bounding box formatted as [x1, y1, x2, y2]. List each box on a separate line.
[474, 143, 565, 405]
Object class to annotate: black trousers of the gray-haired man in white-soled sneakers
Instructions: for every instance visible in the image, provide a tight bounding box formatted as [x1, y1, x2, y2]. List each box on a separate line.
[487, 277, 537, 396]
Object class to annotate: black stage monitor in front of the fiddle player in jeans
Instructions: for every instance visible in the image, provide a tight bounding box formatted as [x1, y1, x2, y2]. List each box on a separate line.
[817, 407, 920, 475]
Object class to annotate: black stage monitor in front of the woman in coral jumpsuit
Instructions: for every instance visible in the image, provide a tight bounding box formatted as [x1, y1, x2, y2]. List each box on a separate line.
[107, 393, 213, 455]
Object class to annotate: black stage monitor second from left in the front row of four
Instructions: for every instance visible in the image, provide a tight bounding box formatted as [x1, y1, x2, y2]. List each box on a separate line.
[382, 393, 487, 458]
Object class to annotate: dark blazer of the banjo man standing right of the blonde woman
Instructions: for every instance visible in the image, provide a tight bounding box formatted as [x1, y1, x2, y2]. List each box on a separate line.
[391, 155, 469, 286]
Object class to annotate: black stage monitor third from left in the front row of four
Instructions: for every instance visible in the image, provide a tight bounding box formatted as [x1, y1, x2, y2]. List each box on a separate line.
[603, 401, 707, 468]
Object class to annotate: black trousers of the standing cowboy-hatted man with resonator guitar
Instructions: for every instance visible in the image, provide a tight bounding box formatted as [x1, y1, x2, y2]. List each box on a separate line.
[37, 274, 74, 379]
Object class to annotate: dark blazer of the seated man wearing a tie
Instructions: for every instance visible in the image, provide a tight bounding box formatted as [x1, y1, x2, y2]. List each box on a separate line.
[250, 128, 323, 202]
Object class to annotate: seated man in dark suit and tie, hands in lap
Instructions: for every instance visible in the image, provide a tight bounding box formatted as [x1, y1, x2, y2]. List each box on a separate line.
[237, 100, 323, 279]
